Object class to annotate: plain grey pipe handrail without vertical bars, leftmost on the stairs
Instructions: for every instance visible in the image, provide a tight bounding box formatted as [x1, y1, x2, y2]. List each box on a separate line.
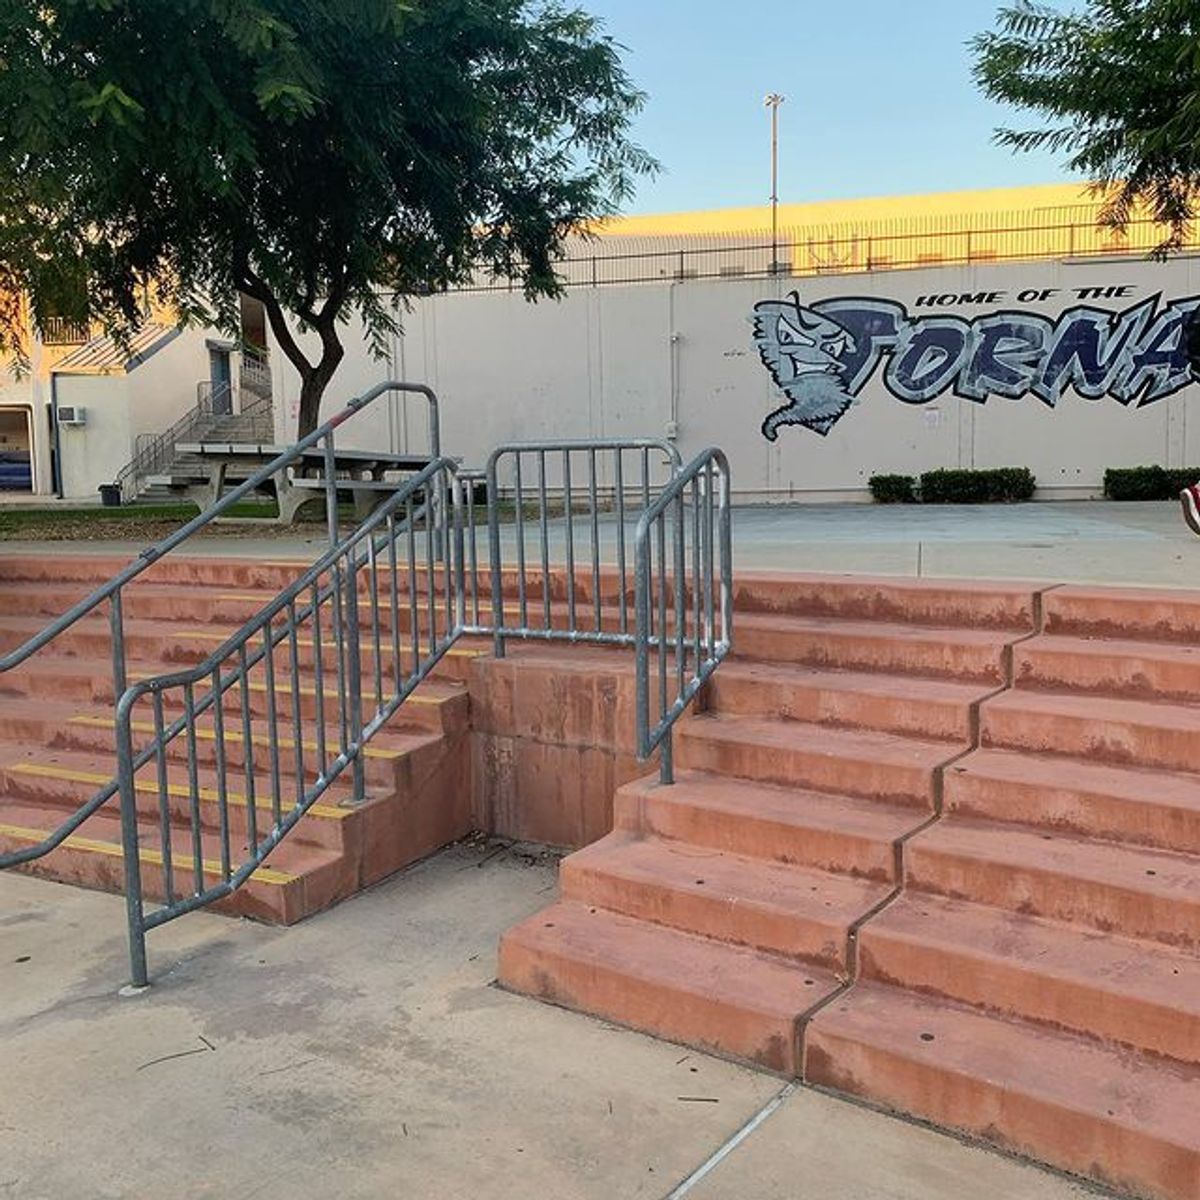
[0, 380, 438, 870]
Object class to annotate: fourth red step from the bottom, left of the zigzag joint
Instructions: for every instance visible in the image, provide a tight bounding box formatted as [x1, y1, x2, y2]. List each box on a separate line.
[676, 713, 955, 809]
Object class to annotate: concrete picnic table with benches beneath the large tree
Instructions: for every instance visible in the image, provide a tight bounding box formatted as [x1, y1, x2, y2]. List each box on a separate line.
[149, 442, 432, 526]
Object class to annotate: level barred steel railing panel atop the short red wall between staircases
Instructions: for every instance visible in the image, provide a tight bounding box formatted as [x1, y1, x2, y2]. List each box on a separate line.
[473, 438, 682, 658]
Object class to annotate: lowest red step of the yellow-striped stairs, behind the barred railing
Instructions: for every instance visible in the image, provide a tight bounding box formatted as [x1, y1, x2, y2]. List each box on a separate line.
[0, 799, 358, 925]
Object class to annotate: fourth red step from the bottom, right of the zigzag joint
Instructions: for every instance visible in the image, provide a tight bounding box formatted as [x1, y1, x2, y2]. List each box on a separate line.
[944, 750, 1200, 854]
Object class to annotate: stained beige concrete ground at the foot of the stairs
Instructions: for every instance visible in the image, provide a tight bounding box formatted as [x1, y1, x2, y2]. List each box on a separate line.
[0, 844, 1093, 1200]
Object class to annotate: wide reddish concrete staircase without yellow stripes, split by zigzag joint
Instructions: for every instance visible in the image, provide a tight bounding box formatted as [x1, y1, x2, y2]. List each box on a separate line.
[500, 578, 1200, 1200]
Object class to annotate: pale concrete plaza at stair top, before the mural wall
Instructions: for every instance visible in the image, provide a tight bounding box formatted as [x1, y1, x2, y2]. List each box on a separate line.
[0, 500, 1200, 587]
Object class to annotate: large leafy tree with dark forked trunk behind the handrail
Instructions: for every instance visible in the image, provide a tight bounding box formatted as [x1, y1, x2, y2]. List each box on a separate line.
[0, 0, 655, 433]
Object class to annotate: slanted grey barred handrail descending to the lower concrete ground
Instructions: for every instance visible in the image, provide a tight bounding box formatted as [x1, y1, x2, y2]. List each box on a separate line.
[116, 458, 464, 986]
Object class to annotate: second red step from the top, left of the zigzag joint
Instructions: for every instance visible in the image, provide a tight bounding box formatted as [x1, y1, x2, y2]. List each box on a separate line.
[722, 612, 1018, 685]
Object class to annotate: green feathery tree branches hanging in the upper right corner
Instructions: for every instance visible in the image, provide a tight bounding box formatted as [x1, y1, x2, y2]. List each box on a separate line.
[972, 0, 1200, 253]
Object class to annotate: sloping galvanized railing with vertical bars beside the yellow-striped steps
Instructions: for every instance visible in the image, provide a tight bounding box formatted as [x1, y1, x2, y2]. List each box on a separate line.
[116, 458, 464, 986]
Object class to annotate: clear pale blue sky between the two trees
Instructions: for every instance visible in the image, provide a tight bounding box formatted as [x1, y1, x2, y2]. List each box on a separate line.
[580, 0, 1072, 212]
